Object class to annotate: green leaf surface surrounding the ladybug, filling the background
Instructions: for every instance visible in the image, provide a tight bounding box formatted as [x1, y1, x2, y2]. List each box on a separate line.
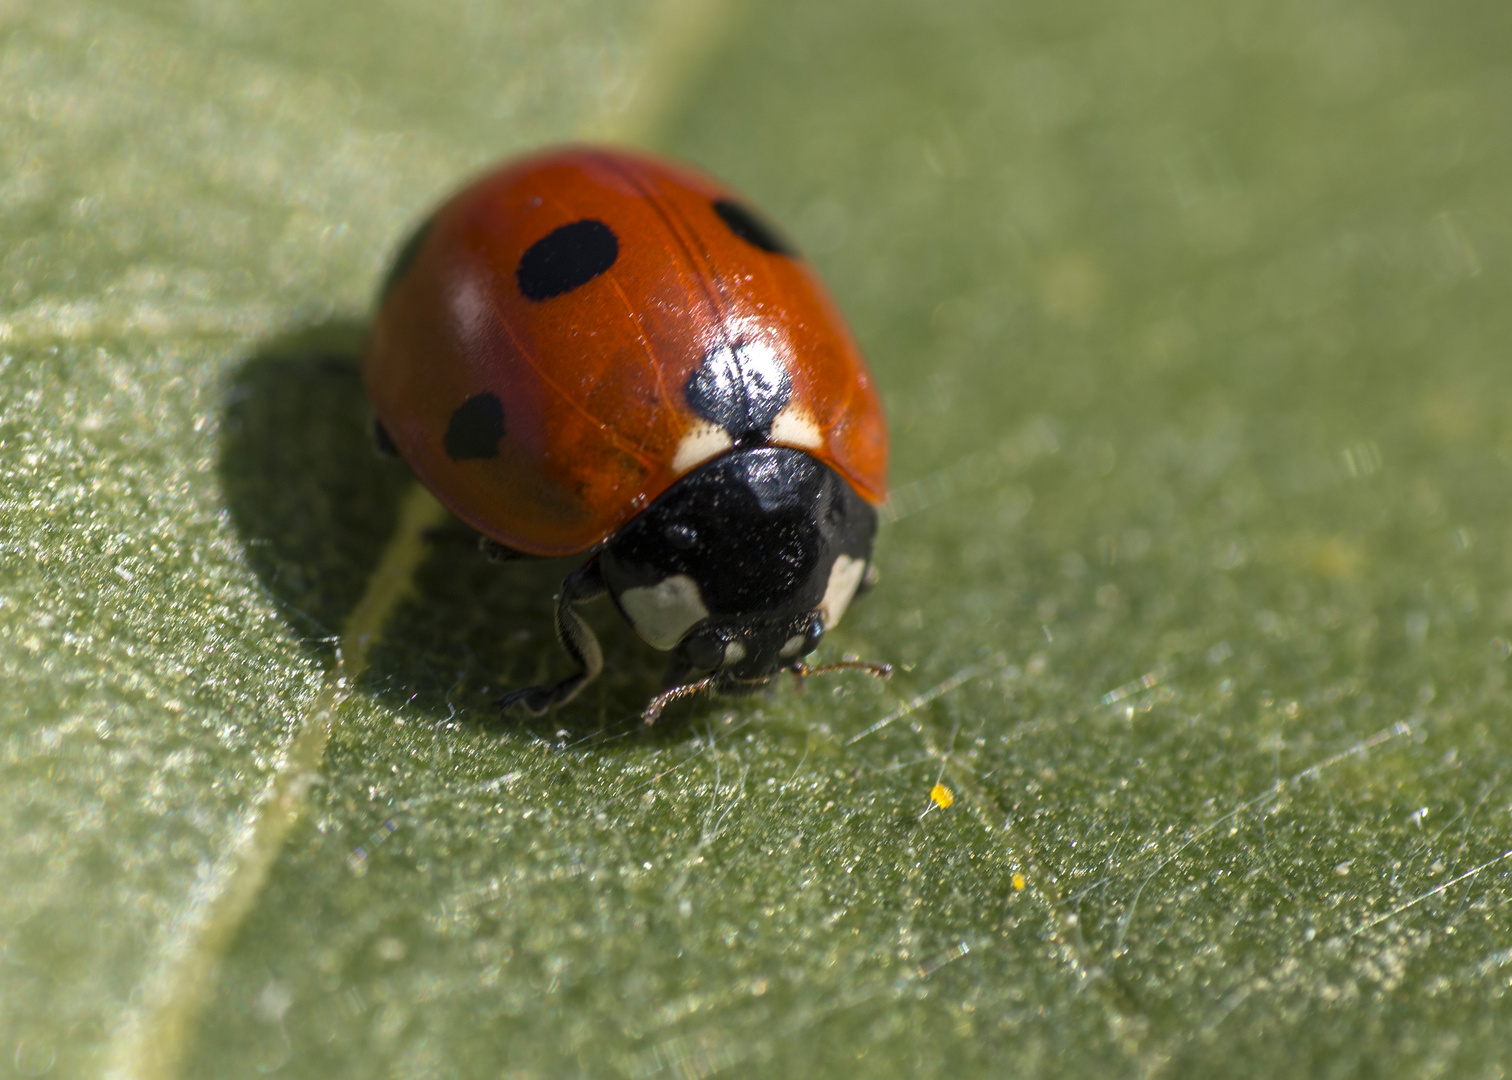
[0, 0, 1512, 1077]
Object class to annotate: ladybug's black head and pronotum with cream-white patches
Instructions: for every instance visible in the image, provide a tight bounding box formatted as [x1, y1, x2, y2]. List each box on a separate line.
[599, 446, 877, 693]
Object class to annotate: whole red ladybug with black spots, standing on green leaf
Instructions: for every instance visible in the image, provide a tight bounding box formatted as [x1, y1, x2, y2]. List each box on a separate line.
[364, 147, 891, 722]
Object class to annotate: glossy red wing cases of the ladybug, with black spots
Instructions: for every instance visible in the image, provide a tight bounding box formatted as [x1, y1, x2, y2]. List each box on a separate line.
[366, 148, 888, 555]
